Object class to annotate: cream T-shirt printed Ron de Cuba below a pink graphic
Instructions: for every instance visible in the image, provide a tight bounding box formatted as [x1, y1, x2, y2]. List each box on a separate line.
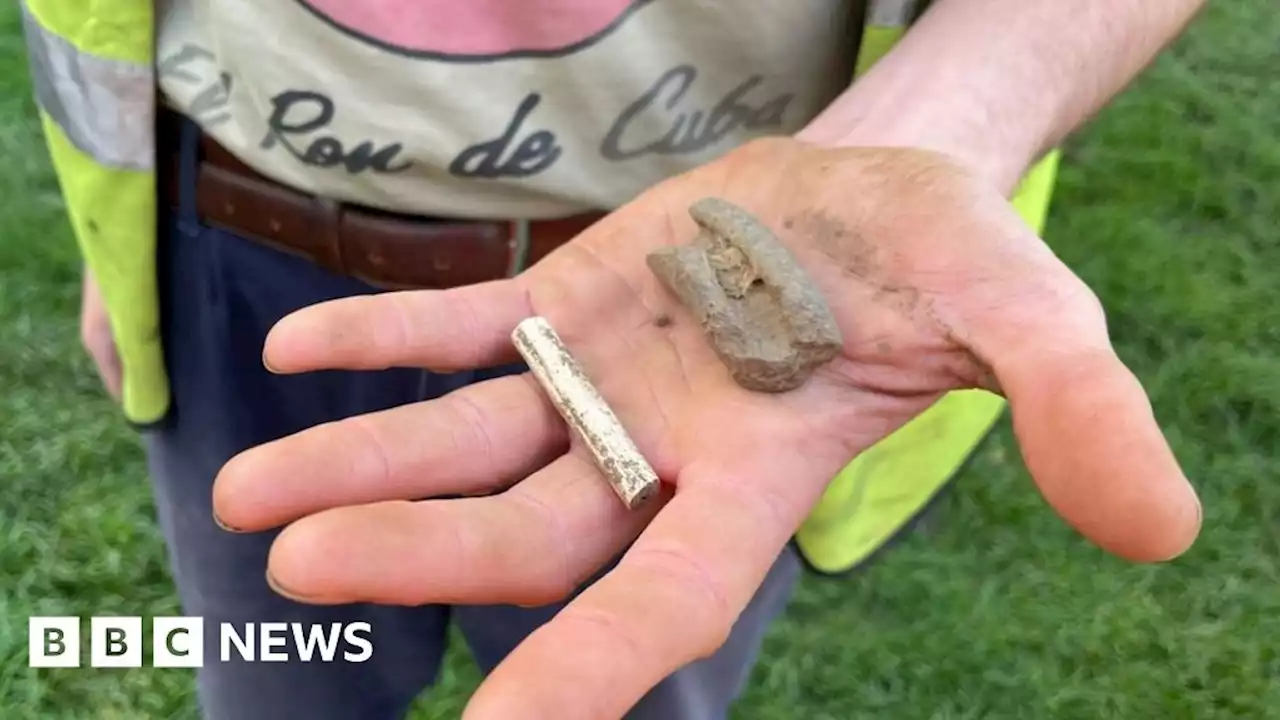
[157, 0, 860, 218]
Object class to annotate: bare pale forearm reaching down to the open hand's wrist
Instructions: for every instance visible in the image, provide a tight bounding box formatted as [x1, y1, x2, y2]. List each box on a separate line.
[799, 0, 1204, 192]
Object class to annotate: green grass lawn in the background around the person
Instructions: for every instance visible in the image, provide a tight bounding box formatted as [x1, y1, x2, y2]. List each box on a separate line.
[0, 0, 1280, 720]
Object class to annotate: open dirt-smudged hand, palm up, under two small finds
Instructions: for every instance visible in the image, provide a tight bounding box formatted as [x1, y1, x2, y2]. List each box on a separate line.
[215, 140, 1199, 719]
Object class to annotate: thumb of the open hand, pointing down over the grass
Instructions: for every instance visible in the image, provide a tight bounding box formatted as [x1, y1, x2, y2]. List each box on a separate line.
[997, 338, 1201, 562]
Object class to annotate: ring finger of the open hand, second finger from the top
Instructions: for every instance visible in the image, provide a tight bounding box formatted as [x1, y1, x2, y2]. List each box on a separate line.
[214, 373, 568, 530]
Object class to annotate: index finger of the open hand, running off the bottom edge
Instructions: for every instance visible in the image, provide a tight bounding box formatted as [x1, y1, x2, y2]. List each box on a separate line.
[465, 453, 833, 720]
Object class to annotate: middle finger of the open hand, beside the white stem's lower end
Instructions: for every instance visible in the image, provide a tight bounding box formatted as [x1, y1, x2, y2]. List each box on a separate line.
[258, 452, 660, 606]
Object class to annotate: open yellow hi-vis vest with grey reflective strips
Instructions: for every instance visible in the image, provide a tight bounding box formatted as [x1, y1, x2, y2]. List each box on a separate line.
[22, 0, 1057, 573]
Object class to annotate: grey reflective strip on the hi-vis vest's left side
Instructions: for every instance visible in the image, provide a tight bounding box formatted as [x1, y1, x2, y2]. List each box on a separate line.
[22, 3, 155, 170]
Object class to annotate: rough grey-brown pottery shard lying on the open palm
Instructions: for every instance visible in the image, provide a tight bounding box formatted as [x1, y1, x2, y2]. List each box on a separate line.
[648, 197, 844, 392]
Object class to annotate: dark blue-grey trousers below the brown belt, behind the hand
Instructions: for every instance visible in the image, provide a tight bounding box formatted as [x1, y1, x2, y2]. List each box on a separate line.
[146, 119, 800, 720]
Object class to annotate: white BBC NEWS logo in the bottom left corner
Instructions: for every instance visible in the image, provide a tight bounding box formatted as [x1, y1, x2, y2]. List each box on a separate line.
[27, 616, 374, 667]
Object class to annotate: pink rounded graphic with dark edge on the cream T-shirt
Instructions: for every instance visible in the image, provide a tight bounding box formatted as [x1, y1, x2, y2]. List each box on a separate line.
[298, 0, 652, 61]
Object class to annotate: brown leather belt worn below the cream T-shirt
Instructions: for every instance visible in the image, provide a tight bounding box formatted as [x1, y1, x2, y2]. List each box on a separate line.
[157, 110, 603, 288]
